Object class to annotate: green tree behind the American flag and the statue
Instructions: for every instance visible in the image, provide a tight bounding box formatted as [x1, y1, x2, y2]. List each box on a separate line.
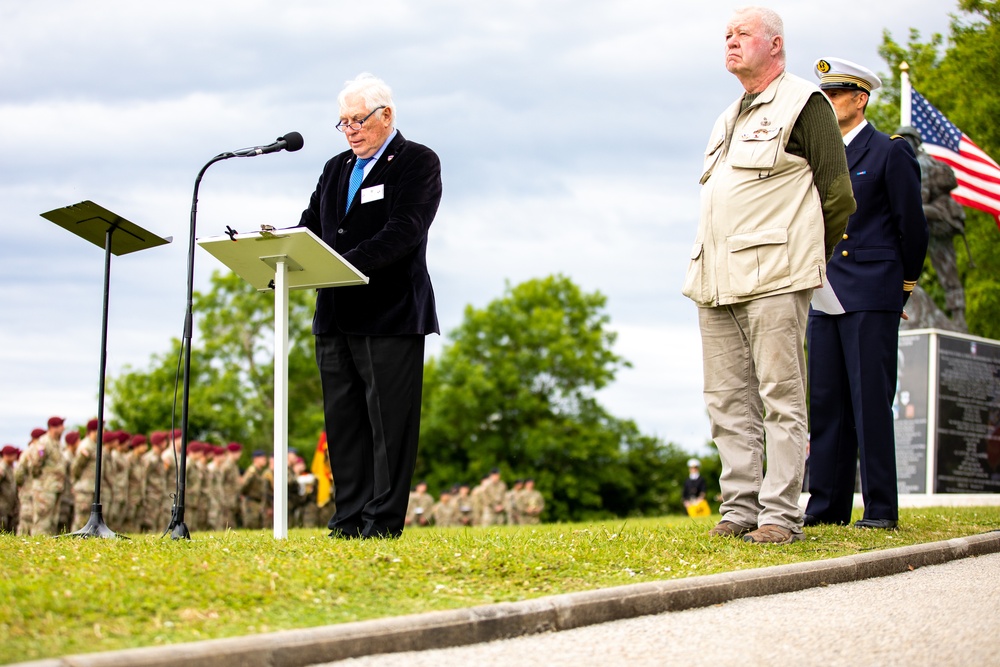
[870, 0, 1000, 339]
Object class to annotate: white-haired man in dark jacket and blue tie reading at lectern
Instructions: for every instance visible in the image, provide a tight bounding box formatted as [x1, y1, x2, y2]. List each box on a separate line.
[299, 74, 441, 538]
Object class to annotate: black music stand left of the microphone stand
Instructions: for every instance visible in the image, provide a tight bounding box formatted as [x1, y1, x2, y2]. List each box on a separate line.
[41, 200, 173, 538]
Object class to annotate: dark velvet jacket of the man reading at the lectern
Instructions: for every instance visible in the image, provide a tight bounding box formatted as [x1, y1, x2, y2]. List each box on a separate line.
[299, 133, 441, 336]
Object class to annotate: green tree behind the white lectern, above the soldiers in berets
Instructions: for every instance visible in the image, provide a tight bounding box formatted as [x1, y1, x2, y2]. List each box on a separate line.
[108, 272, 323, 455]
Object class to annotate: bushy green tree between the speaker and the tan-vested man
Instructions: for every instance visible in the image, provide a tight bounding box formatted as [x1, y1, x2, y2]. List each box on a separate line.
[417, 275, 686, 520]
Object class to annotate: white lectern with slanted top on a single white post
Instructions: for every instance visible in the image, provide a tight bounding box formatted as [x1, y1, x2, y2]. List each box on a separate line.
[198, 227, 368, 539]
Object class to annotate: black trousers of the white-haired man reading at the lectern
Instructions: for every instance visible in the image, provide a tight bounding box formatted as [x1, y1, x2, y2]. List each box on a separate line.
[316, 335, 424, 537]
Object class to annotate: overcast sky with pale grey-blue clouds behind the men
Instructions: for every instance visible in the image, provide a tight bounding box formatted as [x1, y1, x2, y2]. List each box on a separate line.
[0, 0, 956, 451]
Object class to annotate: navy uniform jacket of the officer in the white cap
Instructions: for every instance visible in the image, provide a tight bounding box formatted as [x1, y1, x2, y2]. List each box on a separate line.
[816, 125, 928, 314]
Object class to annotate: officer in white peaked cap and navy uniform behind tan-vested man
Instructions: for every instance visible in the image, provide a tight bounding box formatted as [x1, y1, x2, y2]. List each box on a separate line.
[804, 58, 928, 530]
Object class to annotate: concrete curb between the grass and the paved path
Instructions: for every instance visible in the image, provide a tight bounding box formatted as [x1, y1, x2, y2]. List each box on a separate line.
[15, 531, 1000, 667]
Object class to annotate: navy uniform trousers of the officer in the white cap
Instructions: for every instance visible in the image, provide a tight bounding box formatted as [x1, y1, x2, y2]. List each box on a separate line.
[806, 311, 899, 523]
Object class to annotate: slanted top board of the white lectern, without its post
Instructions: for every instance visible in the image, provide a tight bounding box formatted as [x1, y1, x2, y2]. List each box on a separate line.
[198, 227, 368, 292]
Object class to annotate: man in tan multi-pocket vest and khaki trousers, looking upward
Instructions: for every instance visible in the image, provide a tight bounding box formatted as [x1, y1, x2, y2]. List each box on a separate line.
[683, 7, 854, 544]
